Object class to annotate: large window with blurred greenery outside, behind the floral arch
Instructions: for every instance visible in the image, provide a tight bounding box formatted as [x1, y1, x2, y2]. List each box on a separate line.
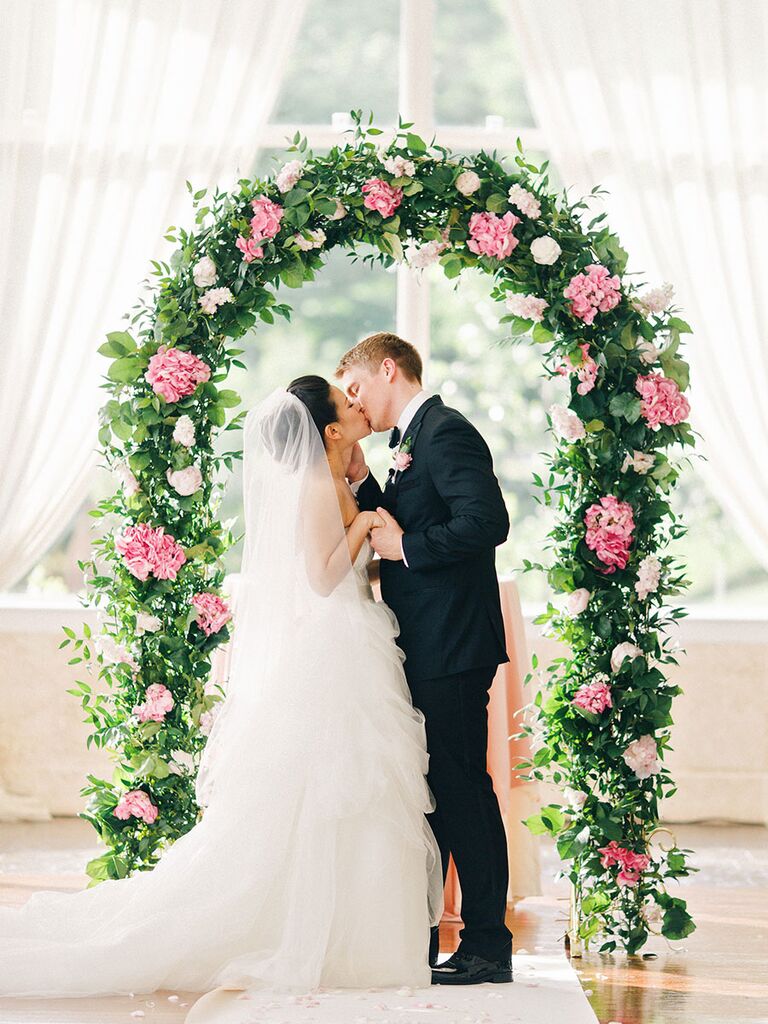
[15, 0, 768, 608]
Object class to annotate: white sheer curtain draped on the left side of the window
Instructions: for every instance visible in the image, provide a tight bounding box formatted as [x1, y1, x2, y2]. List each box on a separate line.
[0, 0, 306, 591]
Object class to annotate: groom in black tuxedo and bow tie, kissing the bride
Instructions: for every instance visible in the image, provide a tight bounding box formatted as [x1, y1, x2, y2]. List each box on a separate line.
[336, 332, 512, 984]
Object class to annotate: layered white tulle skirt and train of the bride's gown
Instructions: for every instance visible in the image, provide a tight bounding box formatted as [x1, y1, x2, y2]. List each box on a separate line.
[0, 584, 442, 996]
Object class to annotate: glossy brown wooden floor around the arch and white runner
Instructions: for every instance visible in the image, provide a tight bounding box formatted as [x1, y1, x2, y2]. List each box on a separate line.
[0, 818, 768, 1024]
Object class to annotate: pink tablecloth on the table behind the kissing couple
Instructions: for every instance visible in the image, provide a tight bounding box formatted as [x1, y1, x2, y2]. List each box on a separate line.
[211, 573, 541, 921]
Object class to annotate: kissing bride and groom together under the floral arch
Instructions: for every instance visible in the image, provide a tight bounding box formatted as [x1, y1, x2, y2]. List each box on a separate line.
[0, 333, 512, 1006]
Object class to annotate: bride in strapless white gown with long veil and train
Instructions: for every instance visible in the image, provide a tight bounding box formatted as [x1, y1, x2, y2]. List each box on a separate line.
[0, 377, 442, 996]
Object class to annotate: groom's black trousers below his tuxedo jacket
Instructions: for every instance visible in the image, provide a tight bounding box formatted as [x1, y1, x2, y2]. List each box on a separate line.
[407, 663, 512, 959]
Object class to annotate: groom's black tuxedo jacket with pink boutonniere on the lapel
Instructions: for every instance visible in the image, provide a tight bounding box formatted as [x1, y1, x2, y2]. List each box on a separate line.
[357, 395, 509, 682]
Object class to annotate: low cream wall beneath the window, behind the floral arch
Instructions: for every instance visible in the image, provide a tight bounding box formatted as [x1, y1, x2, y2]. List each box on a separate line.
[0, 595, 768, 824]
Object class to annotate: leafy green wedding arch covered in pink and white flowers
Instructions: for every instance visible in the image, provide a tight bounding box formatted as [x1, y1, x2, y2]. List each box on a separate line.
[61, 111, 694, 952]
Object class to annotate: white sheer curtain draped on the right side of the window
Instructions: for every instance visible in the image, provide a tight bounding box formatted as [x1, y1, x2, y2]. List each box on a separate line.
[507, 0, 768, 567]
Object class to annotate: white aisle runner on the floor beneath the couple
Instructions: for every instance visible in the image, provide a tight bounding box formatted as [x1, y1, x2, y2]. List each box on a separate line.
[184, 953, 597, 1024]
